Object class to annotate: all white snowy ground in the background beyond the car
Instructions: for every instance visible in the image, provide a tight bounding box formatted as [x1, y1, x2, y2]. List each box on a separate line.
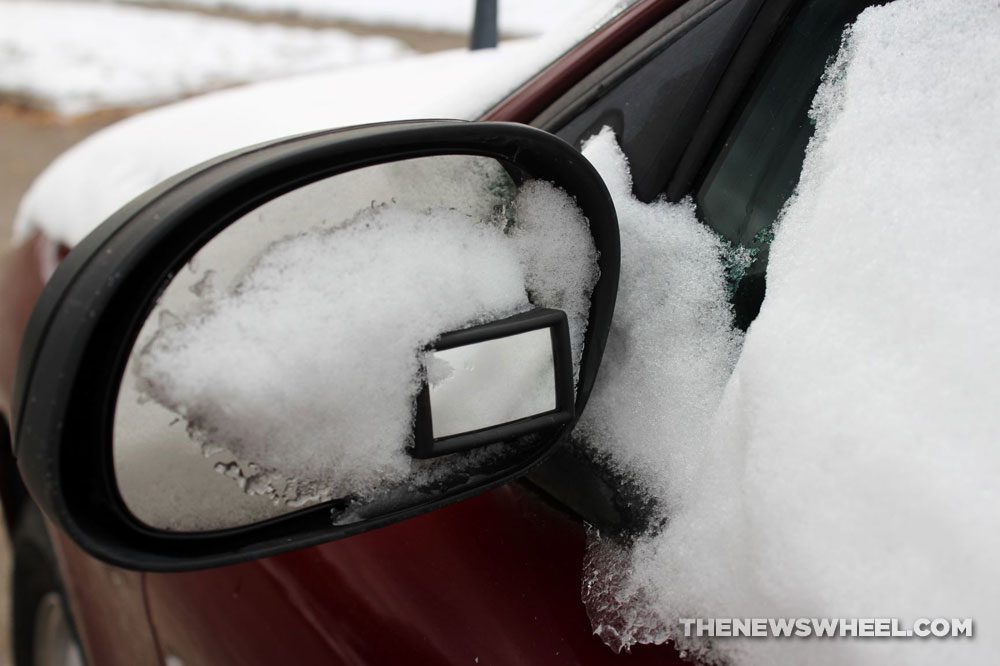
[0, 0, 600, 116]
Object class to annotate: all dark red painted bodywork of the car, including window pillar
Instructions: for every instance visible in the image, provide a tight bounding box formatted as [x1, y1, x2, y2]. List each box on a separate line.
[0, 0, 682, 666]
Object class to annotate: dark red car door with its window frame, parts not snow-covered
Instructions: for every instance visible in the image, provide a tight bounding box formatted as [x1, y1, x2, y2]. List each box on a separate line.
[144, 0, 868, 664]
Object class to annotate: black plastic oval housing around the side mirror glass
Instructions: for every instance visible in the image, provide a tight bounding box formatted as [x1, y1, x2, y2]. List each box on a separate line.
[12, 120, 620, 571]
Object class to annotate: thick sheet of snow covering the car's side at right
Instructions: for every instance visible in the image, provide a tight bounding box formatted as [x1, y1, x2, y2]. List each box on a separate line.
[588, 0, 1000, 664]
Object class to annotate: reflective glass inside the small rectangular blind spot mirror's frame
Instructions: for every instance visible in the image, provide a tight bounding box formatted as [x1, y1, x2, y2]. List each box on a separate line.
[427, 328, 556, 438]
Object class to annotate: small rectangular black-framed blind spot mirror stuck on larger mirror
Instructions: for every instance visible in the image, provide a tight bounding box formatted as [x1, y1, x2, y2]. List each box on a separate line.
[412, 308, 573, 458]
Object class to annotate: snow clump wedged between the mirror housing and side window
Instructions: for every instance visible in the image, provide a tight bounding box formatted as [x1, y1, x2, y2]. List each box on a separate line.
[575, 128, 741, 505]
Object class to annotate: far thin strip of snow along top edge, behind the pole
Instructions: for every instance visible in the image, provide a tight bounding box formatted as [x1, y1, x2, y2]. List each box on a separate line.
[125, 0, 592, 35]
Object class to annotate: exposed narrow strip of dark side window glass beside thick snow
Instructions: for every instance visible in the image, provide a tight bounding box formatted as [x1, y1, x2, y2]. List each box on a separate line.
[695, 0, 874, 329]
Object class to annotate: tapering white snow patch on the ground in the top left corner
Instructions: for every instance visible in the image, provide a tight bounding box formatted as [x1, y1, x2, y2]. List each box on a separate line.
[0, 1, 407, 114]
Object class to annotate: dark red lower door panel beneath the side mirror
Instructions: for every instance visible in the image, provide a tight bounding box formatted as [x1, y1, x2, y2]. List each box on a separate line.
[146, 484, 680, 666]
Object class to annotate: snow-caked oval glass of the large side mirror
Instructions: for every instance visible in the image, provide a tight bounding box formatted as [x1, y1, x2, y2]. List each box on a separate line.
[113, 156, 598, 531]
